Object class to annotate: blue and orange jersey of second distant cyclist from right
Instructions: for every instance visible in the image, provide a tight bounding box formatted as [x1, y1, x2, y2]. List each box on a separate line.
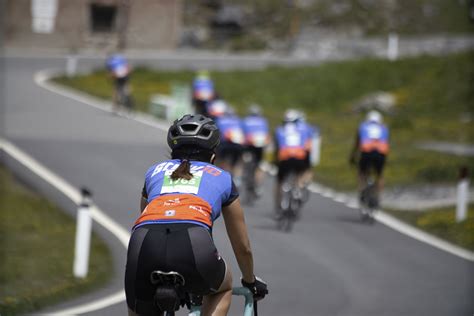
[275, 123, 311, 161]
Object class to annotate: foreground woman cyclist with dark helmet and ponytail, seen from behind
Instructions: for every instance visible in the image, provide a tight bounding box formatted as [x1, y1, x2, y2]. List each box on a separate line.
[125, 114, 268, 315]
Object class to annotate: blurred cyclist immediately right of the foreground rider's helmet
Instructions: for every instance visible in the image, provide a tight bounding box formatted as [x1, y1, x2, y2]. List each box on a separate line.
[215, 106, 245, 181]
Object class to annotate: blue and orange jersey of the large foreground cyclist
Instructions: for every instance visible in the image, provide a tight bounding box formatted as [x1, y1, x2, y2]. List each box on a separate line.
[134, 159, 238, 228]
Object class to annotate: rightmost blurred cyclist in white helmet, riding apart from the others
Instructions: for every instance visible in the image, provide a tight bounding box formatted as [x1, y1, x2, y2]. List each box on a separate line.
[350, 110, 389, 206]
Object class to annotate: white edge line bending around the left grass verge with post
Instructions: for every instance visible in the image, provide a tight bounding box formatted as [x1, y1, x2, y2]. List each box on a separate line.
[0, 138, 130, 316]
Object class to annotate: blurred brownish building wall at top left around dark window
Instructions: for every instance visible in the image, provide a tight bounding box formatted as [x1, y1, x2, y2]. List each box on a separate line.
[4, 0, 182, 50]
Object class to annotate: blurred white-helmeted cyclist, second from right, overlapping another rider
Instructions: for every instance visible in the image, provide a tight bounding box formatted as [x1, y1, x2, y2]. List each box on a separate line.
[274, 109, 312, 209]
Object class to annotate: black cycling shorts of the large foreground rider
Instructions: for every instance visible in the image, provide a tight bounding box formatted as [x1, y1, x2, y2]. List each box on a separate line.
[125, 223, 226, 315]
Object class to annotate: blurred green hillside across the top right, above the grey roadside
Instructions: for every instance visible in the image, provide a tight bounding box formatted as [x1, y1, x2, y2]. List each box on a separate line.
[183, 0, 474, 50]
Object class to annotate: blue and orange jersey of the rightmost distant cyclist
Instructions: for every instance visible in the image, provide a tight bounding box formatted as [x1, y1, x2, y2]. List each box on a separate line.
[359, 122, 389, 154]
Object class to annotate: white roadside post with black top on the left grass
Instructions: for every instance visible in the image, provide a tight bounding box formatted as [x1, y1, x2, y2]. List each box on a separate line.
[73, 188, 92, 278]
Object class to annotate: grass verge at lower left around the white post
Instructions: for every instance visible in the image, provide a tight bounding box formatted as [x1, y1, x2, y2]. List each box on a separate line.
[0, 165, 113, 316]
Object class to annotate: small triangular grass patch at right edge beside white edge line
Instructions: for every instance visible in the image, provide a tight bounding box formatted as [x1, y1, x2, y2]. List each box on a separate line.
[385, 204, 474, 251]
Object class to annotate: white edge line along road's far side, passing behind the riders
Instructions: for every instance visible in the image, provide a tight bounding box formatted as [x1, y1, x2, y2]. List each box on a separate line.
[35, 70, 474, 296]
